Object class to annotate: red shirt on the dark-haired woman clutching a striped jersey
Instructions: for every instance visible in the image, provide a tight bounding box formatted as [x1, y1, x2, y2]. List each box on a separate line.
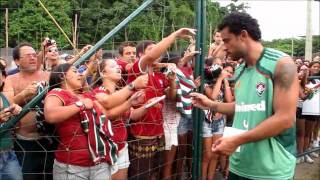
[47, 88, 109, 167]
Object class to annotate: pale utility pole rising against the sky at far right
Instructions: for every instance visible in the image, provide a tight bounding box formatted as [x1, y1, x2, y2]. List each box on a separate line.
[304, 0, 313, 61]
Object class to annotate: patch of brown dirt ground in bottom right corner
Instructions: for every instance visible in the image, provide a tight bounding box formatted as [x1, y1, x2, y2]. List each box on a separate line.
[294, 157, 320, 180]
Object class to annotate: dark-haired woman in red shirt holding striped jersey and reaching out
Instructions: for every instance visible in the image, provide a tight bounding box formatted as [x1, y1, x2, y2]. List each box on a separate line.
[44, 63, 147, 180]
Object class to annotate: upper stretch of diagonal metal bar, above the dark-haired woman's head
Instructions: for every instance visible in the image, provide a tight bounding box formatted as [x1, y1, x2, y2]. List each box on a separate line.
[74, 0, 153, 66]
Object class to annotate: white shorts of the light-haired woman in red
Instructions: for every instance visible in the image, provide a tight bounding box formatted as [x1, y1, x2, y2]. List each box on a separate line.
[111, 143, 130, 174]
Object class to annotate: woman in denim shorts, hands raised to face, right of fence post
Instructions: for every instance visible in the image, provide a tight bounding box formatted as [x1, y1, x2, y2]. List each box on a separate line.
[202, 58, 234, 180]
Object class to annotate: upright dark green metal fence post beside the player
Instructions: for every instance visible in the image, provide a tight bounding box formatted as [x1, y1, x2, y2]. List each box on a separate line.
[192, 0, 206, 180]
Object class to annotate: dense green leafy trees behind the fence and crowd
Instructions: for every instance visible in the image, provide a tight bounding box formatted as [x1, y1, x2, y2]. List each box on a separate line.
[0, 0, 246, 49]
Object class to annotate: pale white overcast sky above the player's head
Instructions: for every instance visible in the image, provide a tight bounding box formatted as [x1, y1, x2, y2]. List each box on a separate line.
[213, 0, 320, 40]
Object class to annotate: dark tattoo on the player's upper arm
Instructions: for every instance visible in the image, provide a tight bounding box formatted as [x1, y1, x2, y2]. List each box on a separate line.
[275, 63, 297, 90]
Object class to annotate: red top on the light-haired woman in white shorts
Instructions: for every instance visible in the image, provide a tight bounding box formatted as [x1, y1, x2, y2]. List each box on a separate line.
[93, 86, 130, 151]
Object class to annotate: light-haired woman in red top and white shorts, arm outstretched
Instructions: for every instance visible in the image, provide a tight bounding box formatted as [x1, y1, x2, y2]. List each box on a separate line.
[93, 59, 148, 180]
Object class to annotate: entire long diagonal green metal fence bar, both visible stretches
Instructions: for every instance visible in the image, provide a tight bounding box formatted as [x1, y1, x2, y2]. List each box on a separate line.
[12, 0, 154, 122]
